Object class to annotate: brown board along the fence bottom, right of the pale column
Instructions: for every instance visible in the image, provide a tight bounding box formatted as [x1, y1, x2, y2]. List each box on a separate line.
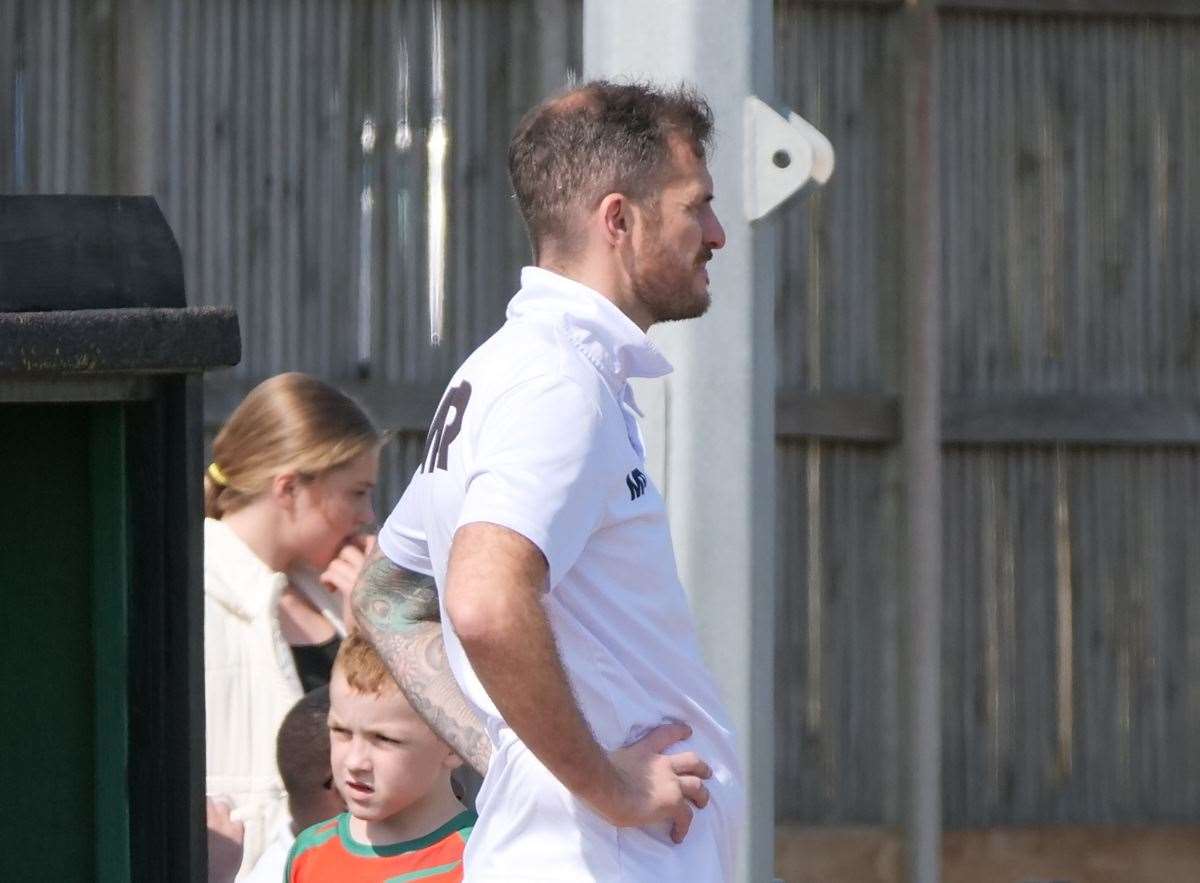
[775, 824, 1200, 883]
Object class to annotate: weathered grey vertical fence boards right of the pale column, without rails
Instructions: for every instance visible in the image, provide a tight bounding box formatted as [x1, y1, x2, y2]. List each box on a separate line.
[776, 2, 1200, 827]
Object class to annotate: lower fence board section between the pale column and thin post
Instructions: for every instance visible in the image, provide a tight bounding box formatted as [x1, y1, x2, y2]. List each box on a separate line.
[775, 442, 899, 823]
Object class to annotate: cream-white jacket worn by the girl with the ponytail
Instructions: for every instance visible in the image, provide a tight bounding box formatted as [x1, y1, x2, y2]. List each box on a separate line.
[204, 518, 346, 878]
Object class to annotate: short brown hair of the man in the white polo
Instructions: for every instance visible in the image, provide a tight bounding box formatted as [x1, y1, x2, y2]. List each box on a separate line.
[509, 80, 713, 259]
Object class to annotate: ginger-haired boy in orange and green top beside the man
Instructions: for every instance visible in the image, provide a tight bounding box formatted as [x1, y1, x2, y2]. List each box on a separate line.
[287, 633, 475, 883]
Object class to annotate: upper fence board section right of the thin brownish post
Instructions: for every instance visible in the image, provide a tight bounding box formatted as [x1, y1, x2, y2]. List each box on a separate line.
[940, 13, 1200, 396]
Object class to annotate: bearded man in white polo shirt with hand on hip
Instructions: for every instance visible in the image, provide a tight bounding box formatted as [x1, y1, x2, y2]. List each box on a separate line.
[355, 82, 742, 883]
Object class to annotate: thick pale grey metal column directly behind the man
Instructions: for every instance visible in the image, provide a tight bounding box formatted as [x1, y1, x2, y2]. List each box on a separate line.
[583, 0, 775, 883]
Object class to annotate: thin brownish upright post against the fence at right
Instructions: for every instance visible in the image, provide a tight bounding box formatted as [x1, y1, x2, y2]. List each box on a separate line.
[900, 0, 942, 883]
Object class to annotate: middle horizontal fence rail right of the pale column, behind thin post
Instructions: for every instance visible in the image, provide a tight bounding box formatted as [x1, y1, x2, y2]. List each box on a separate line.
[775, 389, 1200, 446]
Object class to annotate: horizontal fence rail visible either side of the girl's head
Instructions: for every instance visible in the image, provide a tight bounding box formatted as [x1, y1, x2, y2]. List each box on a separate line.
[204, 376, 443, 436]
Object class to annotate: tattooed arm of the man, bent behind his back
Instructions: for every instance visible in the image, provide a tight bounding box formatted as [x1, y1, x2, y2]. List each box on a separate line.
[353, 552, 492, 774]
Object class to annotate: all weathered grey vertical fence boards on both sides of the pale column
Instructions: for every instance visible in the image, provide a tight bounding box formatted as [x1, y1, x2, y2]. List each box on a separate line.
[9, 0, 1200, 825]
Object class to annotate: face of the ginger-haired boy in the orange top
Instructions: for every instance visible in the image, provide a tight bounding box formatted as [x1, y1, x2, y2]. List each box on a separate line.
[329, 671, 461, 822]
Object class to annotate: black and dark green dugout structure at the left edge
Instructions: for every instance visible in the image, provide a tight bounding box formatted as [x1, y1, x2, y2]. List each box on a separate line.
[0, 196, 241, 882]
